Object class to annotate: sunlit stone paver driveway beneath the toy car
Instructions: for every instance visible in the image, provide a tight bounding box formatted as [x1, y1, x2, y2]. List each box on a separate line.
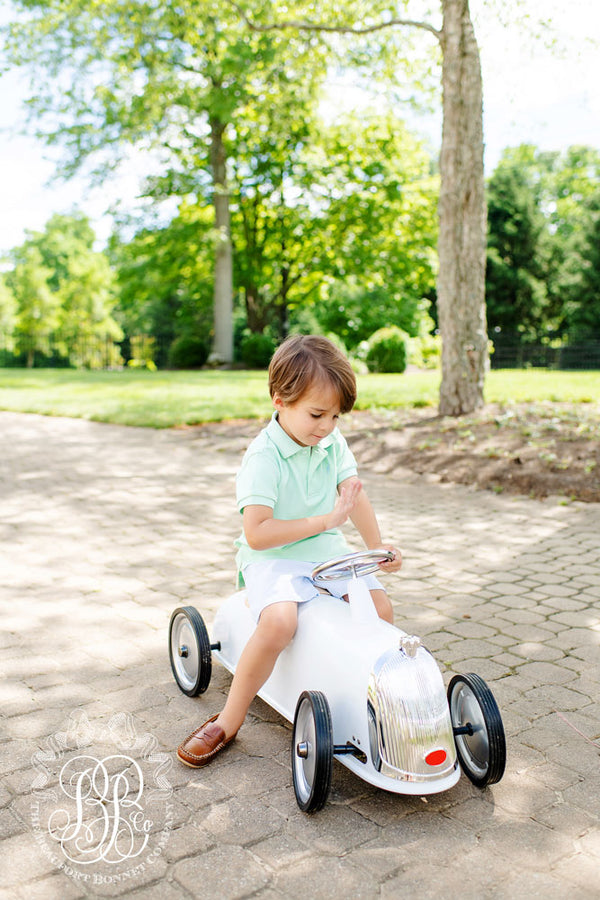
[0, 413, 600, 900]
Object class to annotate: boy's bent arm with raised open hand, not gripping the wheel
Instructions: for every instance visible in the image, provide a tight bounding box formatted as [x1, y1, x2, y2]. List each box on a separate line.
[243, 478, 361, 550]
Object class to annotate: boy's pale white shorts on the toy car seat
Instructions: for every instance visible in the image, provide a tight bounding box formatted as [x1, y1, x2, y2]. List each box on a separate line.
[242, 559, 385, 622]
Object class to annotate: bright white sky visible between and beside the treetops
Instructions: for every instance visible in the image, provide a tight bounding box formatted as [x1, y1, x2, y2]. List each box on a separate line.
[0, 0, 600, 255]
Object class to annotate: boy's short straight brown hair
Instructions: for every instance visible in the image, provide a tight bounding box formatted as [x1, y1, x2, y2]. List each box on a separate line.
[269, 334, 356, 413]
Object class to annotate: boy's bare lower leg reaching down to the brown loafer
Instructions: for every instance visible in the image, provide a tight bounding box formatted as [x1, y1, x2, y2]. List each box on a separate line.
[217, 604, 298, 738]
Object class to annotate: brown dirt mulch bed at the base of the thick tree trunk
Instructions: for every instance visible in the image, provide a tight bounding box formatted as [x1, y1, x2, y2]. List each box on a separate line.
[343, 403, 600, 503]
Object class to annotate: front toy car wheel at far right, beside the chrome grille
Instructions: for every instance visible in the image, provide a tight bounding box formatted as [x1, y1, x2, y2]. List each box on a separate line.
[448, 672, 506, 788]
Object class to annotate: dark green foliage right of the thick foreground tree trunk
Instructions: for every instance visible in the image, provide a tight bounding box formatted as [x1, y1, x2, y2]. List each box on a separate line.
[486, 145, 600, 340]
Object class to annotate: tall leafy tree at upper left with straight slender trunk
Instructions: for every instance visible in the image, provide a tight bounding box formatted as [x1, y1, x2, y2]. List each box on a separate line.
[8, 0, 324, 361]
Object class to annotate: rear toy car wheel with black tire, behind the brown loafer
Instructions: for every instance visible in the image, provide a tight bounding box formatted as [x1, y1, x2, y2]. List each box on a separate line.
[169, 606, 212, 697]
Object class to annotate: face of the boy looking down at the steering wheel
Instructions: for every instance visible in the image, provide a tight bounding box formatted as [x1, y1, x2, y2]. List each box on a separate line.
[273, 384, 340, 447]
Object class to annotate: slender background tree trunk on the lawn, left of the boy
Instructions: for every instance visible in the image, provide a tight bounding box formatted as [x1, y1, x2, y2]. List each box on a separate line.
[210, 118, 233, 363]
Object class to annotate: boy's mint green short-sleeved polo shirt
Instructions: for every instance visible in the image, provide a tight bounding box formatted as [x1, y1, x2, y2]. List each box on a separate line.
[235, 413, 357, 572]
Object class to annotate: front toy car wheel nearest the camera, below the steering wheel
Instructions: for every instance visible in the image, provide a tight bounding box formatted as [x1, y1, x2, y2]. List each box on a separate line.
[292, 691, 333, 813]
